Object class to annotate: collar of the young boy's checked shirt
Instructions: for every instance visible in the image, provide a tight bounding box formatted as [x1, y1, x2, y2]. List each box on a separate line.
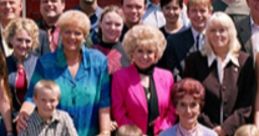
[32, 109, 61, 126]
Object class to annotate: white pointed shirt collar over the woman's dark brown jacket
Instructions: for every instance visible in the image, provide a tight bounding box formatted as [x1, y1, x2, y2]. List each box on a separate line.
[208, 52, 240, 67]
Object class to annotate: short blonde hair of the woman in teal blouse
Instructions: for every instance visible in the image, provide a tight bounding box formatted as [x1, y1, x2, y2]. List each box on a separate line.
[57, 10, 91, 37]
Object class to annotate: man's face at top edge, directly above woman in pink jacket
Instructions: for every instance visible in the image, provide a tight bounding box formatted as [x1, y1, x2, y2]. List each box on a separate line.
[122, 0, 145, 26]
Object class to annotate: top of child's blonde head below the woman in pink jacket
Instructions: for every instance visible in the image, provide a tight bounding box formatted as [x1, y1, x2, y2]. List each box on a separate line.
[116, 125, 143, 136]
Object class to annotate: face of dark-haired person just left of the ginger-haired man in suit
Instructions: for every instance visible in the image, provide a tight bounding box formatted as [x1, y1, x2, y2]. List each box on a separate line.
[162, 0, 182, 24]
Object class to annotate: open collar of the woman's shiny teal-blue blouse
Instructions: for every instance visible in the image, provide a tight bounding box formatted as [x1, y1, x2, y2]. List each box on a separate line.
[55, 44, 90, 68]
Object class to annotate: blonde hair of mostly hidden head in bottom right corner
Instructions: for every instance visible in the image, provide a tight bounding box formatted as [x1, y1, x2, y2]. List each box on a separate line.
[234, 124, 259, 136]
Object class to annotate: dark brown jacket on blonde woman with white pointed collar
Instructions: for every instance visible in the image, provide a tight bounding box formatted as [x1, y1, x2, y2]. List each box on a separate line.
[184, 52, 255, 135]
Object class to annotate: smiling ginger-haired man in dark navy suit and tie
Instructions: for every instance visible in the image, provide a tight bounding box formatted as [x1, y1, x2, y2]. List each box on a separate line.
[158, 0, 212, 80]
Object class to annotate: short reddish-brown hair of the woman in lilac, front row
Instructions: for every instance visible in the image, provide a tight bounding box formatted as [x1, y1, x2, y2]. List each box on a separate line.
[171, 78, 205, 108]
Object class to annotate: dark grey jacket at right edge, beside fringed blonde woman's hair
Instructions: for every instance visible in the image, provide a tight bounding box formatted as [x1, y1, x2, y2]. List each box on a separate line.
[236, 16, 253, 55]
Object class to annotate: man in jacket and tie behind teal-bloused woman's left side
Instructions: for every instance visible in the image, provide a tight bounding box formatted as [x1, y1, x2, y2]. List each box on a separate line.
[37, 0, 65, 55]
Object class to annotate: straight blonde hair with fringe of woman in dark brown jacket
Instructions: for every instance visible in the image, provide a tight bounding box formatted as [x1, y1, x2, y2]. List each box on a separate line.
[202, 12, 241, 55]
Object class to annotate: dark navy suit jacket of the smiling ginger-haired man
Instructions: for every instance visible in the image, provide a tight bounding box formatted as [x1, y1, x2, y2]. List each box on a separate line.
[158, 28, 194, 79]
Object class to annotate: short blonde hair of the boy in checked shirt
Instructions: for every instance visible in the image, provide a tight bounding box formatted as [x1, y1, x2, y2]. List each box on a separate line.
[34, 80, 60, 99]
